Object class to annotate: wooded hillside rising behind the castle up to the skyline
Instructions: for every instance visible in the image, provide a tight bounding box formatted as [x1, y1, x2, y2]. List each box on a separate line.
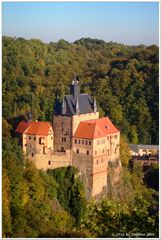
[2, 37, 159, 144]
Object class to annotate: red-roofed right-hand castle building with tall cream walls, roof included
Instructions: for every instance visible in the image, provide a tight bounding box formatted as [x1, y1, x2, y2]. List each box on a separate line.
[73, 117, 120, 197]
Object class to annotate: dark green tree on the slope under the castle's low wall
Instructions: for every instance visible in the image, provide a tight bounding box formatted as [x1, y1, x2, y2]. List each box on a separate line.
[49, 167, 87, 226]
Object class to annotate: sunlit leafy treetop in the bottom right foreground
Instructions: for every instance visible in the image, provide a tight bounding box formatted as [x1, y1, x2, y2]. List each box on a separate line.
[85, 196, 159, 238]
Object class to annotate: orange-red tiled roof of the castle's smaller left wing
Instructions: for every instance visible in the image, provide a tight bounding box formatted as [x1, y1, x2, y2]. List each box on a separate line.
[16, 122, 52, 136]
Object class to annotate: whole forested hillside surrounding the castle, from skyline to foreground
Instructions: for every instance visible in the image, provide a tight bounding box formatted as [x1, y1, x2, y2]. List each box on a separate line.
[2, 37, 159, 238]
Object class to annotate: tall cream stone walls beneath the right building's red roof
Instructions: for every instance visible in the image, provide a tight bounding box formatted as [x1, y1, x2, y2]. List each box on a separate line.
[72, 133, 120, 197]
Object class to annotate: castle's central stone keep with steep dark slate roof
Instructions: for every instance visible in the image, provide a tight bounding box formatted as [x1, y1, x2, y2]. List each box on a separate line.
[53, 80, 99, 152]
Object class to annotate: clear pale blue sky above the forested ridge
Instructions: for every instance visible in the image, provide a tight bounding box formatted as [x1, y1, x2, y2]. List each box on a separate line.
[2, 2, 159, 45]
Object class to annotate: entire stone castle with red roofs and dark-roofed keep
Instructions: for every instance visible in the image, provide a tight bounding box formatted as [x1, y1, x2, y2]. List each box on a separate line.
[16, 80, 121, 197]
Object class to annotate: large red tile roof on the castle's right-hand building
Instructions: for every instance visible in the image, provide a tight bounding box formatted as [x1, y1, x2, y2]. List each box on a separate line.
[74, 117, 119, 139]
